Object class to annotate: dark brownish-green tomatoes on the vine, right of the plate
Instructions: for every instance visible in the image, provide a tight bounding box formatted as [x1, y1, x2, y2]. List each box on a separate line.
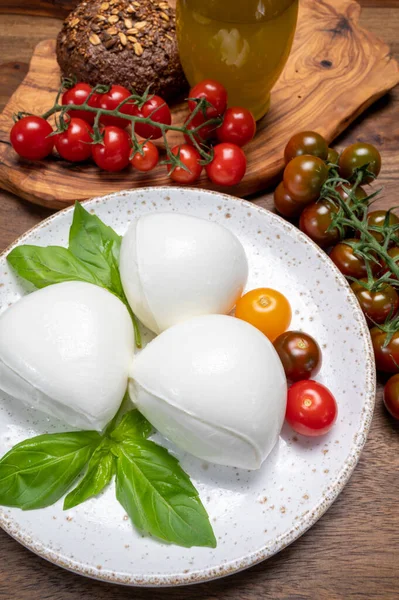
[274, 131, 399, 418]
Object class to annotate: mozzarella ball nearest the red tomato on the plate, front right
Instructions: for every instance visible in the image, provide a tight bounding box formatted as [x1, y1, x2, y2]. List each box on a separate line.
[129, 315, 287, 469]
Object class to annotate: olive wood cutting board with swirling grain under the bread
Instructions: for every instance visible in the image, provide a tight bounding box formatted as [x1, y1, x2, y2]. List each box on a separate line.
[0, 0, 399, 208]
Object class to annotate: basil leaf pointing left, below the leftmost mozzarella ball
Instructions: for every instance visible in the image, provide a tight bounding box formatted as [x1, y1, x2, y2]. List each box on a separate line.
[0, 431, 101, 510]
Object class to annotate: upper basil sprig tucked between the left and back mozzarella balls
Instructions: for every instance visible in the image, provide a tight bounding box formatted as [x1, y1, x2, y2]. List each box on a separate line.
[7, 202, 141, 348]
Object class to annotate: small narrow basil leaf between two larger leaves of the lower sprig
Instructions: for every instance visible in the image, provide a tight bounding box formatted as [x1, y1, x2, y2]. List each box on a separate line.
[64, 439, 115, 510]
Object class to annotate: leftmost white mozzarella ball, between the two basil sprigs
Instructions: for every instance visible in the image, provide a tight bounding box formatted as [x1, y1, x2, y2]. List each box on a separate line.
[0, 282, 134, 431]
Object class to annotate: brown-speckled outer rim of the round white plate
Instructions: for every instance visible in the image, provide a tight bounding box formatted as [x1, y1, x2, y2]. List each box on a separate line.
[0, 186, 376, 587]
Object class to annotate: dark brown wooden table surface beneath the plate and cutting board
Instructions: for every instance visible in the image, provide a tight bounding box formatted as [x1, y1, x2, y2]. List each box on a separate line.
[0, 0, 399, 600]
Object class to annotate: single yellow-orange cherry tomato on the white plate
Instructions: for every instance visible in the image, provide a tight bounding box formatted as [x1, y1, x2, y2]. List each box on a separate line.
[236, 288, 292, 342]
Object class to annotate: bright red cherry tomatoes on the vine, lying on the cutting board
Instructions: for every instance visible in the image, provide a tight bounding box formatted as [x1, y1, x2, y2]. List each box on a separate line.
[10, 80, 256, 186]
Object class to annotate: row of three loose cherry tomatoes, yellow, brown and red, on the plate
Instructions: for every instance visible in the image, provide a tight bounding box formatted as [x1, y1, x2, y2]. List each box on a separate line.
[236, 288, 338, 437]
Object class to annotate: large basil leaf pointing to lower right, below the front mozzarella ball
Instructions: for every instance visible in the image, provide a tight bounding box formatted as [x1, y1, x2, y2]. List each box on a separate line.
[116, 439, 216, 548]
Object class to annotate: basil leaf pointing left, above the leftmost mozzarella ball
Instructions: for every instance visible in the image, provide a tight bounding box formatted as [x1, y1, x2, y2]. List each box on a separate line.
[7, 245, 102, 288]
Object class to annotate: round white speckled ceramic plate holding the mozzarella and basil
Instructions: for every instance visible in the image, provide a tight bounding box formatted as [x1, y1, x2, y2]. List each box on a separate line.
[0, 188, 375, 586]
